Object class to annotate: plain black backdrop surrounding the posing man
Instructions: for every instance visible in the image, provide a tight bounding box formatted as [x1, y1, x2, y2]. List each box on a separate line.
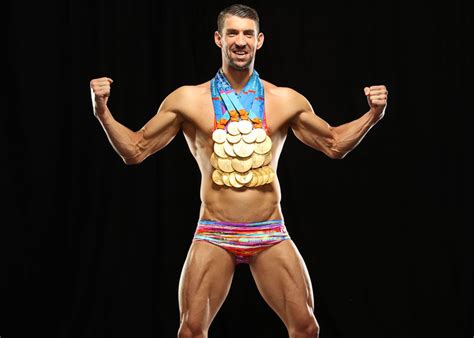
[0, 0, 473, 338]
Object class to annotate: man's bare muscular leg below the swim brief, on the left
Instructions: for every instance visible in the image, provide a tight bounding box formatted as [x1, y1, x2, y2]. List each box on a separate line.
[178, 241, 235, 338]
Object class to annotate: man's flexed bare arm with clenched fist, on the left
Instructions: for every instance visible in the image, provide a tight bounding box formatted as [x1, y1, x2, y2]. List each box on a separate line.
[90, 77, 182, 164]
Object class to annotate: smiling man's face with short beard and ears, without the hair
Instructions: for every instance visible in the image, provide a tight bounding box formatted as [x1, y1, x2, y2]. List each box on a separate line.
[214, 16, 263, 70]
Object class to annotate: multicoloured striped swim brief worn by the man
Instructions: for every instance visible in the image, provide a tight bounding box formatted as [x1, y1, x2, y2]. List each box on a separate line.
[193, 219, 290, 264]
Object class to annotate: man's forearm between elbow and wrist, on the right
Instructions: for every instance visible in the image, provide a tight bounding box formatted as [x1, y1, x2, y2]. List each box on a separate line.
[332, 109, 383, 158]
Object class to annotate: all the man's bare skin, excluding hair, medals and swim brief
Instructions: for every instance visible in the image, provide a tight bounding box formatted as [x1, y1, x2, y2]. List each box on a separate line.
[91, 12, 388, 338]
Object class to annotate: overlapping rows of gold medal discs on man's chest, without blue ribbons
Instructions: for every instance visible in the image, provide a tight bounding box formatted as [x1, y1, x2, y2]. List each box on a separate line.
[210, 110, 275, 188]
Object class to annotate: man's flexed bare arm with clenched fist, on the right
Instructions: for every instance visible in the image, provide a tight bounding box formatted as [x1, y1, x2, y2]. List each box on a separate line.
[290, 86, 388, 159]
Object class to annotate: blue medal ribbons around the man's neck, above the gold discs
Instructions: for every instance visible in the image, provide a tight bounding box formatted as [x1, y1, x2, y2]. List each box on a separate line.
[211, 69, 267, 129]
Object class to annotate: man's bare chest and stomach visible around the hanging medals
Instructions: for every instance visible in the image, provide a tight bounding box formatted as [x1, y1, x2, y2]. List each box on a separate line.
[176, 80, 296, 222]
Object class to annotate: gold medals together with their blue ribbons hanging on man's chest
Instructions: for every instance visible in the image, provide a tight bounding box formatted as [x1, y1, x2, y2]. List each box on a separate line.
[210, 70, 275, 188]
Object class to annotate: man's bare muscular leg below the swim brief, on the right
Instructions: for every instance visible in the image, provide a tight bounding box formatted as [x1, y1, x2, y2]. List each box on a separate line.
[250, 240, 319, 338]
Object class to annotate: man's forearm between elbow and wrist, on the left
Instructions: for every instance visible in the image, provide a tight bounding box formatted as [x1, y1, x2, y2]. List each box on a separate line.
[96, 108, 140, 164]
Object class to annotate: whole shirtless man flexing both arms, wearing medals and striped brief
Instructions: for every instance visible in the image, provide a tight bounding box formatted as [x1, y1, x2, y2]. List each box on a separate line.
[90, 5, 388, 338]
